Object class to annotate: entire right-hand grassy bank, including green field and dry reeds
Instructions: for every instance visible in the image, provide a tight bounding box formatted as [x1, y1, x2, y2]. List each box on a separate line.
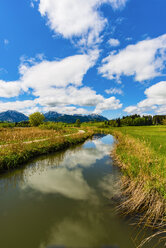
[111, 126, 166, 228]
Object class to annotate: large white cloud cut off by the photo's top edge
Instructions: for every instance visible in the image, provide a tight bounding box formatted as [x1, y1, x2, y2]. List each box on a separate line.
[39, 0, 127, 44]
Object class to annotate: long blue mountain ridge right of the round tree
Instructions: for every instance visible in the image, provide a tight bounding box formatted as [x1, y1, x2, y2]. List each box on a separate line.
[44, 111, 108, 123]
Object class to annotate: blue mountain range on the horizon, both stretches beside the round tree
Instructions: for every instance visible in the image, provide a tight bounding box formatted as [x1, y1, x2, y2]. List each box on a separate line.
[0, 110, 108, 123]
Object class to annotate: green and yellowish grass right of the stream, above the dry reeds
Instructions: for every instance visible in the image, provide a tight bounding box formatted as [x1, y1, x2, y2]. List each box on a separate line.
[113, 126, 166, 199]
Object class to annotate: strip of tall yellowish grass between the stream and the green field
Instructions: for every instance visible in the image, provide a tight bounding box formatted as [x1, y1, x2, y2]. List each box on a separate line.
[113, 131, 166, 223]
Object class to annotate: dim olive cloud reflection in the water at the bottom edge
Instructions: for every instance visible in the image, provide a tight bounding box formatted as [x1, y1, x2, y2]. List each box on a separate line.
[39, 212, 121, 248]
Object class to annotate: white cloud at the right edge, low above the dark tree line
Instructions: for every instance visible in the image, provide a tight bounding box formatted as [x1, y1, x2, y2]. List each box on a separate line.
[125, 81, 166, 114]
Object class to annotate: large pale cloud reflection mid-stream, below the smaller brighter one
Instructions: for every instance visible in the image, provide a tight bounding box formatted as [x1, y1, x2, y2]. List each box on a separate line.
[22, 167, 94, 200]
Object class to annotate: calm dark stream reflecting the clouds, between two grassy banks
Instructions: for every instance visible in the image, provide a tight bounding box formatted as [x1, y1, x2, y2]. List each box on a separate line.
[0, 135, 163, 248]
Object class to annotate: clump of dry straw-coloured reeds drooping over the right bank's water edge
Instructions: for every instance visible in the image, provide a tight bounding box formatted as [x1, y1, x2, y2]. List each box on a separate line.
[120, 177, 166, 228]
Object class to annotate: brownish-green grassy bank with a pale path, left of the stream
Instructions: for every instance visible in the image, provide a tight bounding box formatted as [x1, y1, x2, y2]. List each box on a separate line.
[0, 128, 93, 173]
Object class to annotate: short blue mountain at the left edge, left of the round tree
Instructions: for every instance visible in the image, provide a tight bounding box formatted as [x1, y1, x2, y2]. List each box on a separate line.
[0, 110, 29, 122]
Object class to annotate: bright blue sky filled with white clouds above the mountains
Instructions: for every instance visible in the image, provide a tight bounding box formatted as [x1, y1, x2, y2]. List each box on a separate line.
[0, 0, 166, 119]
